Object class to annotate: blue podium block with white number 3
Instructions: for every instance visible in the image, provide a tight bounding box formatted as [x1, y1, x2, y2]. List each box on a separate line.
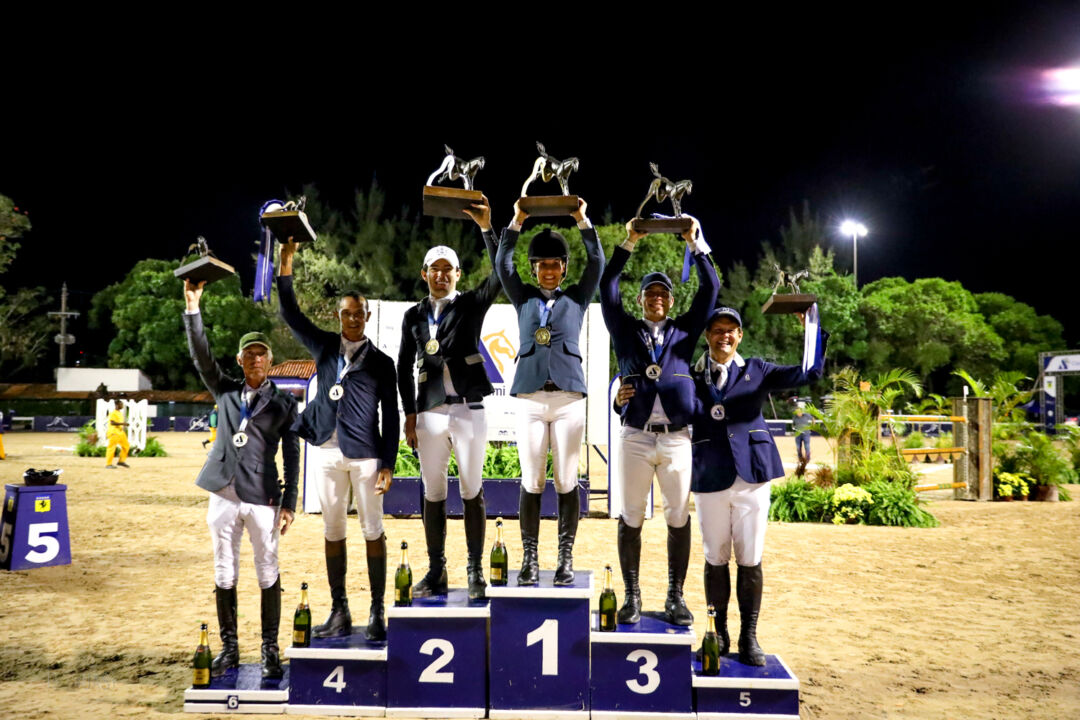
[590, 612, 694, 720]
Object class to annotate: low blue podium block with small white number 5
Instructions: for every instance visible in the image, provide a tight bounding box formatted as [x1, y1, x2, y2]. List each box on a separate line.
[693, 652, 799, 720]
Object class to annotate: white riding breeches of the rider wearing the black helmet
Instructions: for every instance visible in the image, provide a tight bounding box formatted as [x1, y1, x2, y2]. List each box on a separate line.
[516, 390, 585, 494]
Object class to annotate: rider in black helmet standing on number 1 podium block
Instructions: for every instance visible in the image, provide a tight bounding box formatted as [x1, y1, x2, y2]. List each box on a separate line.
[495, 199, 604, 585]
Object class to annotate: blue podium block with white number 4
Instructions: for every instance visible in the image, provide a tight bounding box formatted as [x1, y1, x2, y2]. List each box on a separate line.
[285, 630, 387, 718]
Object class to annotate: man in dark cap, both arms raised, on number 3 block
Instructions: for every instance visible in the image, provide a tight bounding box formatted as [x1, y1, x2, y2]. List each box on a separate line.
[600, 220, 719, 625]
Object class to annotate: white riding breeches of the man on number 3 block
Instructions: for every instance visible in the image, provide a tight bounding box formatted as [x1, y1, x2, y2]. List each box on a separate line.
[619, 425, 693, 528]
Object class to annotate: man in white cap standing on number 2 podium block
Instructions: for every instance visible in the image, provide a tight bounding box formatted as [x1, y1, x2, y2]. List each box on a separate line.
[397, 198, 500, 599]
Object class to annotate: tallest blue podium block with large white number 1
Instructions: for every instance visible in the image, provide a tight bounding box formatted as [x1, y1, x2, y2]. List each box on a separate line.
[487, 570, 593, 720]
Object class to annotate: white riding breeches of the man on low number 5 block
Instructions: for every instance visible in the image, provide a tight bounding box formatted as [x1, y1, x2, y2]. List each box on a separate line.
[693, 477, 771, 567]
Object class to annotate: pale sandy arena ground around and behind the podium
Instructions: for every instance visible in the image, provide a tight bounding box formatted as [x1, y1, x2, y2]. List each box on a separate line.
[0, 433, 1080, 720]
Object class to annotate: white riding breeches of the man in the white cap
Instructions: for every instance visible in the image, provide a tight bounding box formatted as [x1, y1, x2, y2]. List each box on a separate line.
[416, 403, 487, 502]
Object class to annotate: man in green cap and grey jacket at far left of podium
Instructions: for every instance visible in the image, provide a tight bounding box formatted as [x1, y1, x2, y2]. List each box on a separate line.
[184, 281, 300, 679]
